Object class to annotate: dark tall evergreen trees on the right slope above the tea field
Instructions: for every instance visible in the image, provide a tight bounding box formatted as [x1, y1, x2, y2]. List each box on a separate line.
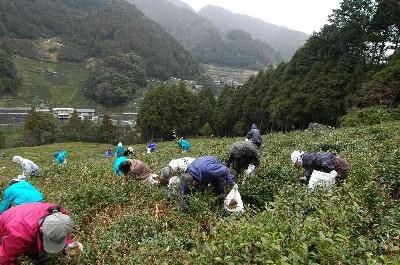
[208, 0, 400, 135]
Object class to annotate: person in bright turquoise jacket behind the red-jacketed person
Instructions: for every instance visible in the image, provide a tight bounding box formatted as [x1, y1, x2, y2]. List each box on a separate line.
[0, 178, 43, 214]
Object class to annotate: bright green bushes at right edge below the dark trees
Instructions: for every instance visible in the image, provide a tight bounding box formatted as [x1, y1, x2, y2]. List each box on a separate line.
[340, 106, 400, 127]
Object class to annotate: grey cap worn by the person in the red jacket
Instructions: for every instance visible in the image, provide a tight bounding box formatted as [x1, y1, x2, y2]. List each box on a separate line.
[42, 212, 72, 254]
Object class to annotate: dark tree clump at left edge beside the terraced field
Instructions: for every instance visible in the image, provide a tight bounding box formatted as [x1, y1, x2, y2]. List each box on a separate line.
[0, 49, 19, 95]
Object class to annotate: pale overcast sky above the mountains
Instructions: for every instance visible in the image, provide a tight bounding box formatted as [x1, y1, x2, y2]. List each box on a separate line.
[182, 0, 341, 34]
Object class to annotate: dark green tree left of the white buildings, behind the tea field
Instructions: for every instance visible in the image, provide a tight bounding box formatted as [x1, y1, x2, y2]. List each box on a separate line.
[23, 108, 58, 146]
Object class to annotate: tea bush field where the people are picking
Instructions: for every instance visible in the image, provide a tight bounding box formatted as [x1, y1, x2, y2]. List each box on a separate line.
[0, 122, 400, 264]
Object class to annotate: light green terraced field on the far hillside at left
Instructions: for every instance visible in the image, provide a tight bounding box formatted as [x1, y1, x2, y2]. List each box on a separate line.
[0, 57, 94, 108]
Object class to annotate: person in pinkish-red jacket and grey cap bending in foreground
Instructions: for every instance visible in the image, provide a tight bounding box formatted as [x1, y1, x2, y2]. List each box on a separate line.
[0, 203, 83, 265]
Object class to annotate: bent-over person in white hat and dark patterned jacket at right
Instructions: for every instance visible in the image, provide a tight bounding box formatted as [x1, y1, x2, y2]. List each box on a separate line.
[290, 150, 350, 183]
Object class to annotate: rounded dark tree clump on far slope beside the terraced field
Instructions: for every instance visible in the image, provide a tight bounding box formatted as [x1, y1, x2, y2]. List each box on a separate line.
[83, 52, 146, 106]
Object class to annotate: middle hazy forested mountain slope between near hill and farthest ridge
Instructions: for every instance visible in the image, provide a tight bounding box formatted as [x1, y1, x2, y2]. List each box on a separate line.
[128, 0, 283, 70]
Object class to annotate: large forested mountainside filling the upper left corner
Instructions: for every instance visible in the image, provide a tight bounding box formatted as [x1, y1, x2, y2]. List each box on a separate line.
[0, 0, 200, 78]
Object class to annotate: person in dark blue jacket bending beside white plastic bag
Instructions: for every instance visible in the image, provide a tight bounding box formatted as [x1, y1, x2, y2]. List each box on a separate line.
[179, 156, 238, 199]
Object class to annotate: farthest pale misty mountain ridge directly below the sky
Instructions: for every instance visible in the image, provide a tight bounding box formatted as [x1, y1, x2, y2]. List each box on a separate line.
[198, 5, 308, 60]
